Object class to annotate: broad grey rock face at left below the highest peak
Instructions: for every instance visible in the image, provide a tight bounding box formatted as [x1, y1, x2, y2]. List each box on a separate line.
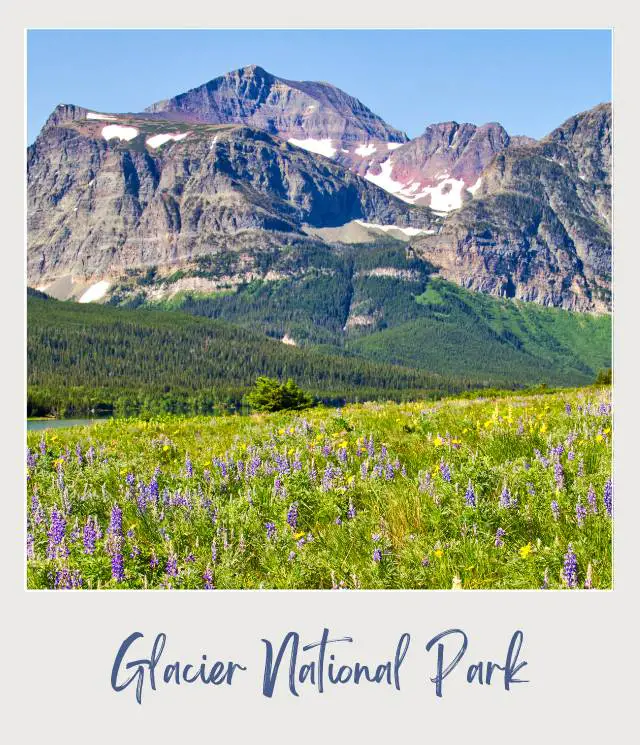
[27, 106, 434, 294]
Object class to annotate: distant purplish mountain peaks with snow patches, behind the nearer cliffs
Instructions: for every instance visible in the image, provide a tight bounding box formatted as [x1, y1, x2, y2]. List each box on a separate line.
[146, 65, 510, 212]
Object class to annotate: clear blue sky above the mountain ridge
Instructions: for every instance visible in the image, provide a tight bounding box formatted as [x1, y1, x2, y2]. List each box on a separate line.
[27, 30, 611, 142]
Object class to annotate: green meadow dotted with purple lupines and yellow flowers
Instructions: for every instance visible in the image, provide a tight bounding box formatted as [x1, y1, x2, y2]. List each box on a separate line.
[27, 388, 612, 589]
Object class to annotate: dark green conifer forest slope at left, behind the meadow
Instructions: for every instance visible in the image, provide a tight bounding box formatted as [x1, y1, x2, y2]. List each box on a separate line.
[27, 293, 484, 416]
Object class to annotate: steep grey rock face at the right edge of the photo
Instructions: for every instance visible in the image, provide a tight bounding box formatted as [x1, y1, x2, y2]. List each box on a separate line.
[414, 104, 611, 311]
